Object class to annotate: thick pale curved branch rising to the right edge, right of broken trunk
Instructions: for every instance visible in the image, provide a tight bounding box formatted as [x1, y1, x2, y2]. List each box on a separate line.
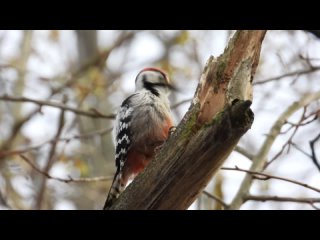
[230, 91, 320, 209]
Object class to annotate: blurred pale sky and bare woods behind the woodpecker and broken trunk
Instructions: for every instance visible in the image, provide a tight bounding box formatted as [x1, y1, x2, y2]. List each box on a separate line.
[0, 30, 320, 209]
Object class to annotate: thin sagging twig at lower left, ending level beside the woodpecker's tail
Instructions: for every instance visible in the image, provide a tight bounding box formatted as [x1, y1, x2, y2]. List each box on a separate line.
[19, 154, 113, 183]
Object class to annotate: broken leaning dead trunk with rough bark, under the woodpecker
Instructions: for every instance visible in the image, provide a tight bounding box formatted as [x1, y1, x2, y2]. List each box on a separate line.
[106, 31, 266, 210]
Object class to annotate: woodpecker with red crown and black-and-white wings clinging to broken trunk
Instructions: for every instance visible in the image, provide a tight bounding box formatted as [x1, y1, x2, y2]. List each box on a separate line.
[104, 67, 174, 209]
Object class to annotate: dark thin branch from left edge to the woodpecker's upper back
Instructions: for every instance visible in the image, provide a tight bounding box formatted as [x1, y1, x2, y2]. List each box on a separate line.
[0, 95, 115, 119]
